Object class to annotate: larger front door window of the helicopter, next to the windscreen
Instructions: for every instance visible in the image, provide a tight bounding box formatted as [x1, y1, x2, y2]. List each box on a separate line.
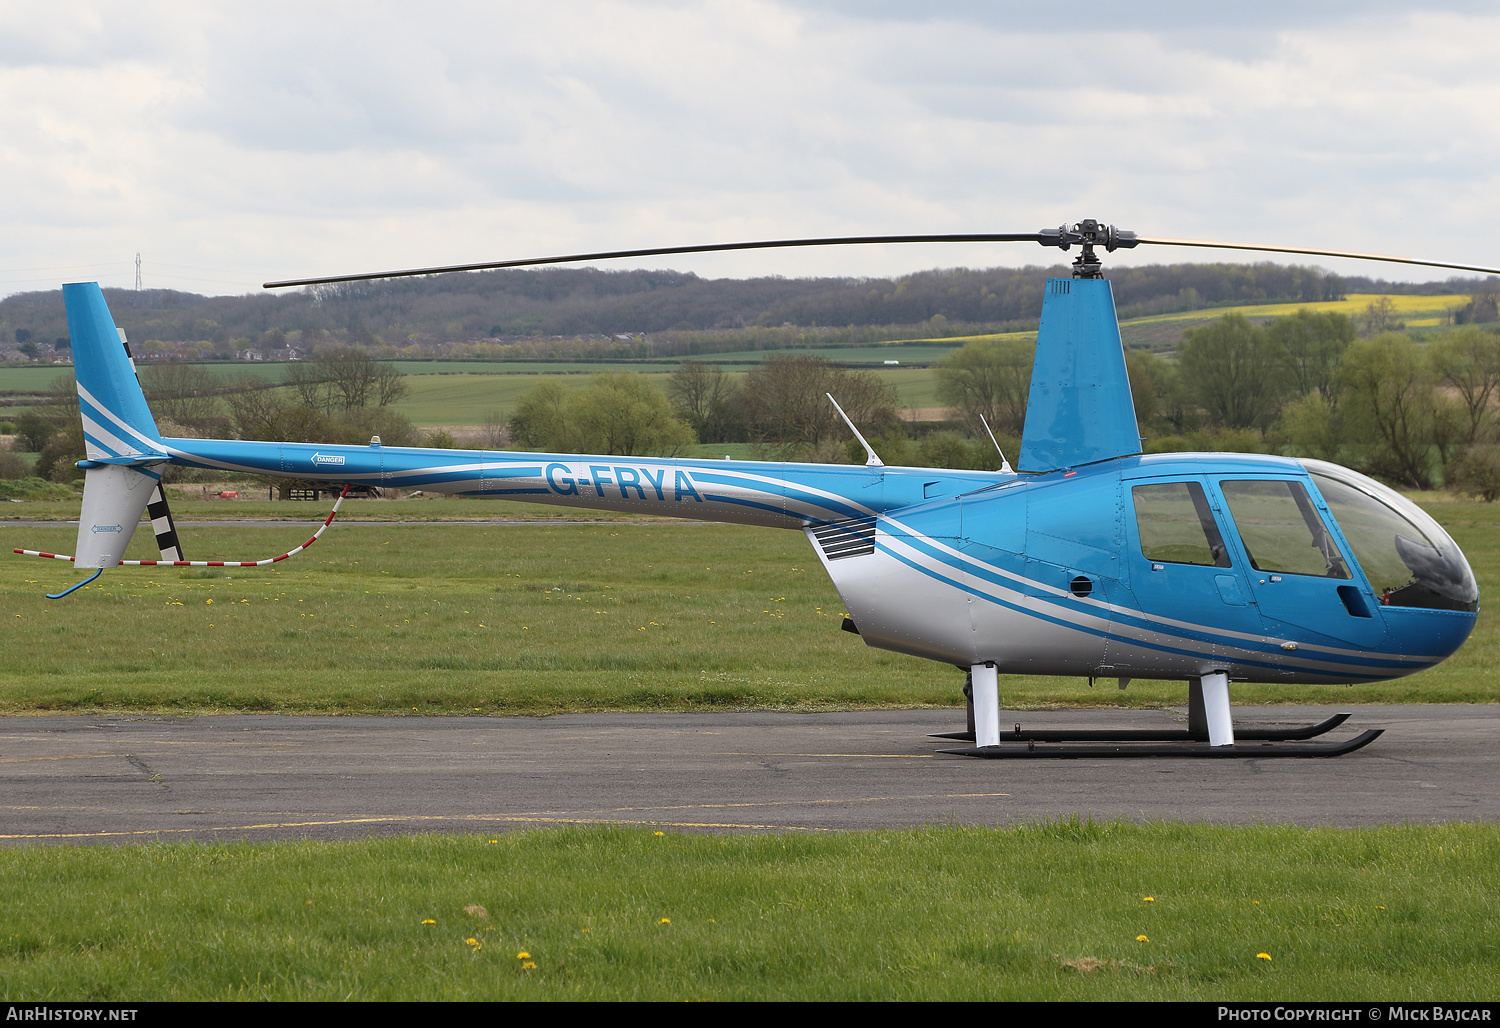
[1220, 480, 1349, 578]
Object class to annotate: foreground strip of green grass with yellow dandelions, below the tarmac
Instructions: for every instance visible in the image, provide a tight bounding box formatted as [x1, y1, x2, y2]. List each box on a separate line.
[0, 819, 1500, 1001]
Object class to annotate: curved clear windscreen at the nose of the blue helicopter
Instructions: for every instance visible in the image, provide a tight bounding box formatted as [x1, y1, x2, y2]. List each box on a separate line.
[1301, 459, 1479, 611]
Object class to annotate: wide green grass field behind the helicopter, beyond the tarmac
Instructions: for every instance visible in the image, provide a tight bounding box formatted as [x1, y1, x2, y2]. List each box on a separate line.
[0, 497, 1500, 714]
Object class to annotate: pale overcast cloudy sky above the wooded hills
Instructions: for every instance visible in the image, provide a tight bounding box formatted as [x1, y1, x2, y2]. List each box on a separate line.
[0, 0, 1500, 294]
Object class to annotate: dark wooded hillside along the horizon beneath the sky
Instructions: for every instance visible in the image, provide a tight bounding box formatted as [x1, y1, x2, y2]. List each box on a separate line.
[0, 263, 1482, 353]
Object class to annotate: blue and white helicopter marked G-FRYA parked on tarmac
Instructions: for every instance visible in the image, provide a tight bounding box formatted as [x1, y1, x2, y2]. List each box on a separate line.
[15, 219, 1494, 758]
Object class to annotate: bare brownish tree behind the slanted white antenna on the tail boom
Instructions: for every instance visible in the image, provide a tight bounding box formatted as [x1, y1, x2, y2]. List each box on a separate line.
[744, 356, 900, 461]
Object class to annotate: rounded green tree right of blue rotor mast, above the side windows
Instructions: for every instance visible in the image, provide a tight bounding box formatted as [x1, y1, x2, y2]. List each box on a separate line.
[1178, 314, 1287, 431]
